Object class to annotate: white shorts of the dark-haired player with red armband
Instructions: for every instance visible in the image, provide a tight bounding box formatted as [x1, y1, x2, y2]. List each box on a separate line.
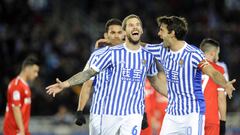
[160, 113, 205, 135]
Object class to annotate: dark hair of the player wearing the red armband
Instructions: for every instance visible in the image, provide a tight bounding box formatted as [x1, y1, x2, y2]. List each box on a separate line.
[157, 16, 188, 40]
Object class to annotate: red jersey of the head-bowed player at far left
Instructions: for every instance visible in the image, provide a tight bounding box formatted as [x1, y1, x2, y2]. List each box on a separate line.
[3, 77, 31, 135]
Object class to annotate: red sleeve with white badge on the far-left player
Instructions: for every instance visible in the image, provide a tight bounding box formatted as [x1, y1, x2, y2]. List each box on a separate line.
[9, 85, 23, 106]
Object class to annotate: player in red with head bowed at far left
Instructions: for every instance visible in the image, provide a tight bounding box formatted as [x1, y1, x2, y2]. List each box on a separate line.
[3, 56, 39, 135]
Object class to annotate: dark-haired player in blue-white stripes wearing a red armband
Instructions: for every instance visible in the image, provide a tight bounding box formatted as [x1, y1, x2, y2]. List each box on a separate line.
[146, 16, 236, 135]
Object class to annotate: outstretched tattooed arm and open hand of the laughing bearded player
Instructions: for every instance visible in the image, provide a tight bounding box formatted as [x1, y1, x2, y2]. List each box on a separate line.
[46, 68, 97, 97]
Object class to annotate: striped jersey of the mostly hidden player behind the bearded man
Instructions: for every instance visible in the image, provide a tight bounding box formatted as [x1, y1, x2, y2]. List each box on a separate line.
[84, 46, 111, 115]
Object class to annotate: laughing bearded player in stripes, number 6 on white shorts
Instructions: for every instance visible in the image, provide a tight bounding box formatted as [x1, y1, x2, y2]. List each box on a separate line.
[46, 15, 167, 135]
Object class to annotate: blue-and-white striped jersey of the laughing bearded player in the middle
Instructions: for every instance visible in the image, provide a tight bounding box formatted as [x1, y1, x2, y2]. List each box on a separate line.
[91, 44, 157, 116]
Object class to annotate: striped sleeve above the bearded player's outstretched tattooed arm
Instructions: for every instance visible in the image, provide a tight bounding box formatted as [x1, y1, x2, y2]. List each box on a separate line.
[90, 49, 112, 72]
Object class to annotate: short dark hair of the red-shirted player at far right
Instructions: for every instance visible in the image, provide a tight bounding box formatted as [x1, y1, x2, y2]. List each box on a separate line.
[200, 38, 220, 52]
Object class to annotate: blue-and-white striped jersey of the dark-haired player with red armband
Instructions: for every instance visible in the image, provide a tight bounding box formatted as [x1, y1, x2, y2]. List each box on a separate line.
[146, 43, 205, 115]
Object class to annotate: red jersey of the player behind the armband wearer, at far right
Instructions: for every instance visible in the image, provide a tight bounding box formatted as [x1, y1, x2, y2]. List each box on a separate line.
[202, 62, 224, 124]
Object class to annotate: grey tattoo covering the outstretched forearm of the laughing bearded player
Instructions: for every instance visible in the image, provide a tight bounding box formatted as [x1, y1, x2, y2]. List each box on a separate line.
[67, 68, 97, 86]
